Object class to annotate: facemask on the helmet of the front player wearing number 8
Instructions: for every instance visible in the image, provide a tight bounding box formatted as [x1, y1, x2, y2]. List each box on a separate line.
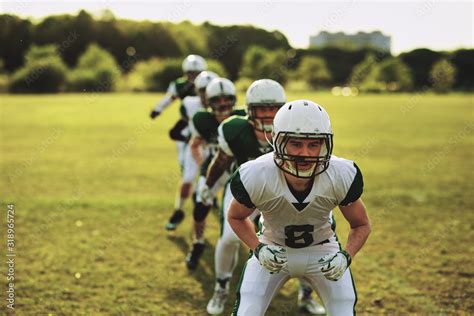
[273, 131, 333, 178]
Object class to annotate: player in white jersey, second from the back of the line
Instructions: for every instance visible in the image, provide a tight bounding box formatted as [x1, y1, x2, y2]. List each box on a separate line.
[166, 71, 219, 230]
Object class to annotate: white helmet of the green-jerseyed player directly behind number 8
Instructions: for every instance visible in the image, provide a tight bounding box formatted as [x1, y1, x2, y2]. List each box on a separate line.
[246, 79, 286, 132]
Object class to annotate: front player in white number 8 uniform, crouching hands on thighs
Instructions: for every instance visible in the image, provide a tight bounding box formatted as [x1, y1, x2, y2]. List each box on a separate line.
[228, 100, 370, 315]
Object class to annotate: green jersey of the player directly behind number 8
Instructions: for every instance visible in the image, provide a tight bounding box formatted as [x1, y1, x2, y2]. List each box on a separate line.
[218, 116, 273, 166]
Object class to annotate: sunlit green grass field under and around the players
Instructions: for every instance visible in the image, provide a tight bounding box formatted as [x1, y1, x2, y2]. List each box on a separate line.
[0, 93, 474, 315]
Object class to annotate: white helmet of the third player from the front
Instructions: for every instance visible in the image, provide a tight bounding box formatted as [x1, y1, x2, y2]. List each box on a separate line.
[206, 78, 237, 122]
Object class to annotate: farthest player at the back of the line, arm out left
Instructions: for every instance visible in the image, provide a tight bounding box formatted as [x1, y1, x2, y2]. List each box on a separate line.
[150, 55, 207, 230]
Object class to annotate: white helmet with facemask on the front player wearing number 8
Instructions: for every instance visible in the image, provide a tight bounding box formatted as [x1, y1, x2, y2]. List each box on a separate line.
[272, 100, 333, 178]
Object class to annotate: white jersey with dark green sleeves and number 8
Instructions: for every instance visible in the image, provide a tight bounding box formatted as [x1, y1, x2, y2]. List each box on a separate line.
[231, 153, 363, 248]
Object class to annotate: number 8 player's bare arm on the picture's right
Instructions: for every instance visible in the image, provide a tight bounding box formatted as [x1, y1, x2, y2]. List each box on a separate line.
[339, 199, 371, 258]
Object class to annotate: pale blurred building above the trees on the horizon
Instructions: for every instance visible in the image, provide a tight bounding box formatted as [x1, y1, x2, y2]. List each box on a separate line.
[309, 31, 392, 52]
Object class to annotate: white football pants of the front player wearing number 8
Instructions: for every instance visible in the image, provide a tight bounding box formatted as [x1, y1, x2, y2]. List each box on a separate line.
[233, 237, 357, 316]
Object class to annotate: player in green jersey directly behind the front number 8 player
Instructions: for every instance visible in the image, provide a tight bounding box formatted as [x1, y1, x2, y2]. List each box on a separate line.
[200, 79, 325, 314]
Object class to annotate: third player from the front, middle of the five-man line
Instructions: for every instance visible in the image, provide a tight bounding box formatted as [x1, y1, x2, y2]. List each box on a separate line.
[186, 78, 246, 270]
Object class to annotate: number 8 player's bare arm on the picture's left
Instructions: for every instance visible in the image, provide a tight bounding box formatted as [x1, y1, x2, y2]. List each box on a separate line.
[227, 199, 259, 250]
